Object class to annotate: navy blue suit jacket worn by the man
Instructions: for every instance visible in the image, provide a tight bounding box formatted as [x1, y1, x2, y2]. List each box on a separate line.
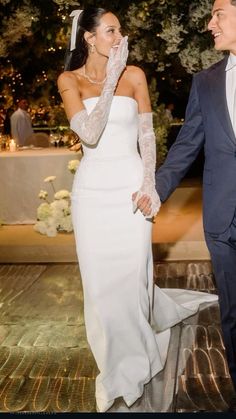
[156, 57, 236, 234]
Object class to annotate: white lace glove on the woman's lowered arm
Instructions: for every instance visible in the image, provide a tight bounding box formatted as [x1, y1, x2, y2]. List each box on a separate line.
[133, 112, 161, 218]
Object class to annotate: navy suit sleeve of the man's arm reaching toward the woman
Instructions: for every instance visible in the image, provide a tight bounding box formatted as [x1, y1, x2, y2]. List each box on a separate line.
[156, 76, 205, 202]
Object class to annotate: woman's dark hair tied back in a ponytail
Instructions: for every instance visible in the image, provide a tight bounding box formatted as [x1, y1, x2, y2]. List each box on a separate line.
[64, 7, 108, 70]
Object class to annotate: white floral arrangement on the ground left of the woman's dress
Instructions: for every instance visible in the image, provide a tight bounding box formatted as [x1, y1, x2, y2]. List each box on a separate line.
[34, 160, 79, 237]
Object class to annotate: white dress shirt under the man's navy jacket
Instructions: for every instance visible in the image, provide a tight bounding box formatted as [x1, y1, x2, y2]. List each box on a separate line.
[225, 53, 236, 136]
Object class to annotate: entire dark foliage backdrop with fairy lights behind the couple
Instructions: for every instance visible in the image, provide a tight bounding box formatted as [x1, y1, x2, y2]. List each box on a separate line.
[0, 0, 224, 160]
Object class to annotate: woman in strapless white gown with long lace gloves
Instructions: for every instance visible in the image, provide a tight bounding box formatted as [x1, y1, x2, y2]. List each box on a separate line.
[58, 7, 217, 412]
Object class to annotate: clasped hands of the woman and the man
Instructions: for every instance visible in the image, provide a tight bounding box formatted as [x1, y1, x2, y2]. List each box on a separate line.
[132, 190, 161, 218]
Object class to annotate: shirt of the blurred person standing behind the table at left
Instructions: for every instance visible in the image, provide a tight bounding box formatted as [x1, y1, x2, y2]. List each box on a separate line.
[11, 108, 34, 146]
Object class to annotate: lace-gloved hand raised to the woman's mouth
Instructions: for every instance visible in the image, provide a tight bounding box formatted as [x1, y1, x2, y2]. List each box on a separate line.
[107, 36, 129, 82]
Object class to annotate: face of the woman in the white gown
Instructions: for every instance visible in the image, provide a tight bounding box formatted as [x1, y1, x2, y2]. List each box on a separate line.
[94, 12, 122, 57]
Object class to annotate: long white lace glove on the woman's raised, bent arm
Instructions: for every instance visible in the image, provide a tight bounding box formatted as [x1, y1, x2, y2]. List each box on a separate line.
[70, 36, 128, 145]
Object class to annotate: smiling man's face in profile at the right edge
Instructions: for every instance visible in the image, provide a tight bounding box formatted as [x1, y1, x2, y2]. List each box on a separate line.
[208, 0, 236, 55]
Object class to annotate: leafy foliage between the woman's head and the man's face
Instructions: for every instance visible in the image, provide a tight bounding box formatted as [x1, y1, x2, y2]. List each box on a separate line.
[125, 0, 224, 106]
